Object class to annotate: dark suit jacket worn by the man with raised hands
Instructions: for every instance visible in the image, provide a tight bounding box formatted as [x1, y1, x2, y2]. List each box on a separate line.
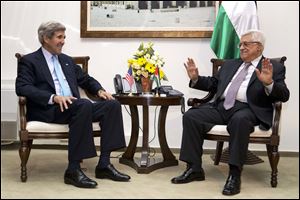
[190, 57, 290, 128]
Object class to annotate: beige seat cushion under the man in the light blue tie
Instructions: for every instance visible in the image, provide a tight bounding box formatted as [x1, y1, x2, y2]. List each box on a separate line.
[26, 121, 101, 133]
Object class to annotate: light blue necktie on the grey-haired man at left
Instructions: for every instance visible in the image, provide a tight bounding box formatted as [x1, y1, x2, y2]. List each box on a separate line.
[51, 56, 72, 96]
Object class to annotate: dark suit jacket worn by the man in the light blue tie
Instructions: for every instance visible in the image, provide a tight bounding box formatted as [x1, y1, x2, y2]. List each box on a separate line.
[16, 48, 103, 122]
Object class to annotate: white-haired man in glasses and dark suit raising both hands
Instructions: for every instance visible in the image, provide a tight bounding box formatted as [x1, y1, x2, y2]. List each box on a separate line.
[171, 30, 289, 195]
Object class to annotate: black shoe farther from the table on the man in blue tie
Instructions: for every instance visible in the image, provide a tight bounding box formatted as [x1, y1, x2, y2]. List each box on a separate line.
[64, 169, 98, 188]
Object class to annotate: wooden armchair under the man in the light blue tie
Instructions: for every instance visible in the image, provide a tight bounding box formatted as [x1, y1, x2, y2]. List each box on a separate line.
[15, 53, 101, 182]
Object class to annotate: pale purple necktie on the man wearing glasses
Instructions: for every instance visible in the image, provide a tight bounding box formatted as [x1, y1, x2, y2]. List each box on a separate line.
[224, 63, 251, 110]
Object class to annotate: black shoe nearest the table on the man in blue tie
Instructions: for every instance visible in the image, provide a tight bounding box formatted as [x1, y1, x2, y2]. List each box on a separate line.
[95, 164, 130, 181]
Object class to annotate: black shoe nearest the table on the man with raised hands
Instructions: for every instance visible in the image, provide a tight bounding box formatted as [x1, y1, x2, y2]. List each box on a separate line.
[171, 167, 205, 184]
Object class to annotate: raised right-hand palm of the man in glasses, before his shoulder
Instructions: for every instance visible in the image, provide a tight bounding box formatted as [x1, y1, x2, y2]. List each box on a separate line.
[255, 58, 273, 86]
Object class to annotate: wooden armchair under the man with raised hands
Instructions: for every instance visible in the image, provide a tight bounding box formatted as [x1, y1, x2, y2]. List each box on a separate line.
[188, 56, 287, 187]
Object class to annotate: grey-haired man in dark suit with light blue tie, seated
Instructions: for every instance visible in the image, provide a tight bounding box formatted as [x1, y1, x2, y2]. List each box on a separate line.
[16, 21, 130, 188]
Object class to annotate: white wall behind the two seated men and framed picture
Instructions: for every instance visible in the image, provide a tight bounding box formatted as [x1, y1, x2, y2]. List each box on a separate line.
[1, 1, 299, 152]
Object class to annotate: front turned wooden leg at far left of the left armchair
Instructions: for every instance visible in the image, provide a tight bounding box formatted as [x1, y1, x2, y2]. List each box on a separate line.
[19, 140, 32, 182]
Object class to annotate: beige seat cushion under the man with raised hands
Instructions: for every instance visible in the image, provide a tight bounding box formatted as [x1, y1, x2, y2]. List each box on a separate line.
[207, 125, 272, 137]
